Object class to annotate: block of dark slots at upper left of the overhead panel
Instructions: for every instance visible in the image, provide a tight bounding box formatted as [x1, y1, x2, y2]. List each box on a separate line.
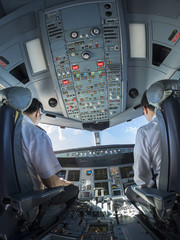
[47, 21, 63, 39]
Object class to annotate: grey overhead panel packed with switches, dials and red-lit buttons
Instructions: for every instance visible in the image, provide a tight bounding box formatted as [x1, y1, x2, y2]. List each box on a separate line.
[42, 2, 123, 123]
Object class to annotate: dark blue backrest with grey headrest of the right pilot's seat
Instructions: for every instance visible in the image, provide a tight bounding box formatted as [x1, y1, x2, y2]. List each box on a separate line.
[147, 80, 180, 194]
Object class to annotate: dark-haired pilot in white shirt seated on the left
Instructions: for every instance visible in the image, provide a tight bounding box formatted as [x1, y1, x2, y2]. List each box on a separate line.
[21, 98, 79, 205]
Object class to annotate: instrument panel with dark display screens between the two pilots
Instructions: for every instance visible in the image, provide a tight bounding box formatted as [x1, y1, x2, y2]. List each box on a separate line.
[58, 164, 133, 200]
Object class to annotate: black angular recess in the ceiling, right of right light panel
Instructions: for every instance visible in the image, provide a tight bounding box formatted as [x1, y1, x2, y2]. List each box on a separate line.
[152, 43, 171, 67]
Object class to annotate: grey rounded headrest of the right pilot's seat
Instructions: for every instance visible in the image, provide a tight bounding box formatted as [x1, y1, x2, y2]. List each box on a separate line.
[146, 80, 180, 109]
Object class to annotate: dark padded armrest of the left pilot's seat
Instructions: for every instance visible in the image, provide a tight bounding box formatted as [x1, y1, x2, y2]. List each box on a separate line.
[11, 187, 64, 212]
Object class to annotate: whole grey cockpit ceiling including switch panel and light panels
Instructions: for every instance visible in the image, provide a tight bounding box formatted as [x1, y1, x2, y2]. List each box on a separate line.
[0, 0, 180, 131]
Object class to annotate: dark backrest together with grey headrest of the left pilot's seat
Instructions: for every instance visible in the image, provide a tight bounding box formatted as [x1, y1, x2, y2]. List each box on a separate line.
[0, 87, 32, 198]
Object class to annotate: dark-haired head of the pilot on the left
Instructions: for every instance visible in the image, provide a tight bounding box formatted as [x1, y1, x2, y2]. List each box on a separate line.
[24, 98, 43, 125]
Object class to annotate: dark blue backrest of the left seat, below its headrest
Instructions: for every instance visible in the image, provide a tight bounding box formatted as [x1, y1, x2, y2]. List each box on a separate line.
[0, 106, 20, 197]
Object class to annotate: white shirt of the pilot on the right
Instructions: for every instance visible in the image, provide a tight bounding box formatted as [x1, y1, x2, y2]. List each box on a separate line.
[134, 115, 162, 187]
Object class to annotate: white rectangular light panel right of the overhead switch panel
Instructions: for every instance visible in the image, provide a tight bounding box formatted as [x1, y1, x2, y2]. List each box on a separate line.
[129, 23, 146, 58]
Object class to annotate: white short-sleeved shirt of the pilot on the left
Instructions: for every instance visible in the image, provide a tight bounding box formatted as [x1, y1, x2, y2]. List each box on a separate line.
[21, 115, 61, 190]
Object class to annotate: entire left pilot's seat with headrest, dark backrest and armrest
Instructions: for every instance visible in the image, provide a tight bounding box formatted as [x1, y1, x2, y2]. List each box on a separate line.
[0, 87, 63, 239]
